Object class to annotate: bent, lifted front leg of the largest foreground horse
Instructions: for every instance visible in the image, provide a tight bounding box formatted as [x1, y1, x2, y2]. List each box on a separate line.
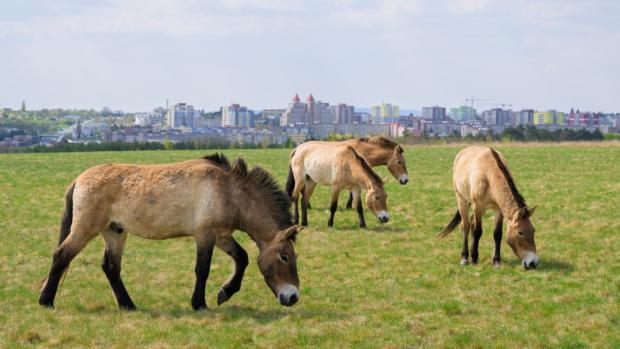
[215, 235, 248, 305]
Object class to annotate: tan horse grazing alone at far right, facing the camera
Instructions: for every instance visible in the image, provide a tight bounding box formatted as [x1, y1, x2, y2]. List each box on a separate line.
[439, 146, 538, 269]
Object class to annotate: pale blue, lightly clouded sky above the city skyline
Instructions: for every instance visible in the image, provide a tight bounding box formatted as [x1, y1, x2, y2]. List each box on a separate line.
[0, 0, 620, 112]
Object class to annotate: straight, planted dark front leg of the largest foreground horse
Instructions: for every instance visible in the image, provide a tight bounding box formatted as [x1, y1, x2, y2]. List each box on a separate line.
[192, 233, 215, 310]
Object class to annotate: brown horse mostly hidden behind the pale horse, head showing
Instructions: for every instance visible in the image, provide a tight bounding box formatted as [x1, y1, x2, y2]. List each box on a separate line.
[308, 136, 409, 208]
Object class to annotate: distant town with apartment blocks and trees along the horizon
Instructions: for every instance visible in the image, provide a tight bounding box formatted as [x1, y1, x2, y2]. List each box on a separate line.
[0, 94, 620, 151]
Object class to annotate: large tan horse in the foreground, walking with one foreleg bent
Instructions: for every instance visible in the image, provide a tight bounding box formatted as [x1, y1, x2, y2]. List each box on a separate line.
[39, 154, 299, 310]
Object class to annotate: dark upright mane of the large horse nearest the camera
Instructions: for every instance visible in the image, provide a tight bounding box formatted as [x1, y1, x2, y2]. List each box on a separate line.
[203, 153, 293, 229]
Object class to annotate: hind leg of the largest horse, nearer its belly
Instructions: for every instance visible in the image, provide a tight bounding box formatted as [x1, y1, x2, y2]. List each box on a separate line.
[101, 229, 136, 310]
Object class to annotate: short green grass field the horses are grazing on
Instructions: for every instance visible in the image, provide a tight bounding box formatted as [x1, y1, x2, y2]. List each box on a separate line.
[0, 144, 620, 348]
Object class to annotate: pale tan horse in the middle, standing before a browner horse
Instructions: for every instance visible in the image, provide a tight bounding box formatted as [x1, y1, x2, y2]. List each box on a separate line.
[286, 142, 389, 228]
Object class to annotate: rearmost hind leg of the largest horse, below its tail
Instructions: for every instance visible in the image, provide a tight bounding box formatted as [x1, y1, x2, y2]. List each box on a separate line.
[39, 218, 97, 308]
